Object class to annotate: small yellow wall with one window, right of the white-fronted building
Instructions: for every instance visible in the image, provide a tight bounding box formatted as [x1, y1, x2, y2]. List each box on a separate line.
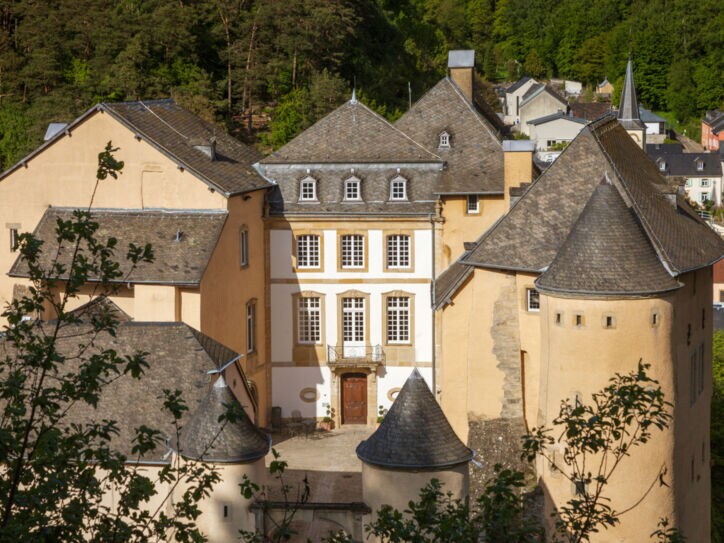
[439, 195, 509, 270]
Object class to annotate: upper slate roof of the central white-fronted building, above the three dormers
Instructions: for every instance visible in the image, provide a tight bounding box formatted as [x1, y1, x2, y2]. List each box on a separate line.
[260, 100, 441, 165]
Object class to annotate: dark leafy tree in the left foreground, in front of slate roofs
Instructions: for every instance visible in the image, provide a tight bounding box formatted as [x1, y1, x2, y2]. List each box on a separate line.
[0, 142, 219, 542]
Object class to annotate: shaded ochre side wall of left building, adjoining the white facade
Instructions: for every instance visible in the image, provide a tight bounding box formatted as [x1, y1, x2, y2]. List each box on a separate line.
[199, 190, 271, 426]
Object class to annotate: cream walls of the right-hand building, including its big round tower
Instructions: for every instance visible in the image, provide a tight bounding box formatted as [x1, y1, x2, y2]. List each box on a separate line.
[438, 262, 713, 542]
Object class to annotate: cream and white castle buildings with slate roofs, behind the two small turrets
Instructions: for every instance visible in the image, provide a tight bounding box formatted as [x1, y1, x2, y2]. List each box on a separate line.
[0, 51, 724, 541]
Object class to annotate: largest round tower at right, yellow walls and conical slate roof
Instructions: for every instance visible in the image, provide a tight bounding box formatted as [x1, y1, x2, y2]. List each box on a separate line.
[536, 178, 711, 542]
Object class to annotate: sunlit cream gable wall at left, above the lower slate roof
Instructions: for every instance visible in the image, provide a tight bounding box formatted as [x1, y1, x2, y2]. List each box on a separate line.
[0, 109, 226, 324]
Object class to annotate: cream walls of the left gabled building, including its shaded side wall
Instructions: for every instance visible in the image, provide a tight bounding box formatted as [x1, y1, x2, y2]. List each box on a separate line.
[0, 110, 271, 425]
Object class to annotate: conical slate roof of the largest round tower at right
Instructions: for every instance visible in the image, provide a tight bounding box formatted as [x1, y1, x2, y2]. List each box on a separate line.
[536, 178, 680, 295]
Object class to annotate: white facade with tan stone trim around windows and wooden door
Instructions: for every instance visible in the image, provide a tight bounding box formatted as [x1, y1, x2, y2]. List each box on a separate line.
[267, 218, 434, 425]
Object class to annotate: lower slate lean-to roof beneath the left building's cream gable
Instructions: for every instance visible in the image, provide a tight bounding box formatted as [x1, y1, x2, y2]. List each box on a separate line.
[9, 208, 227, 285]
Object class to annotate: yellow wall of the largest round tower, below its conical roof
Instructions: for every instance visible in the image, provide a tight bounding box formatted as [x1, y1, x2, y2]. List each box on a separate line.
[537, 269, 712, 542]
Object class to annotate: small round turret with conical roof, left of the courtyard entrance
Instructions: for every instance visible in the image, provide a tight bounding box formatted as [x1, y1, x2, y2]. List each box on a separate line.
[176, 376, 271, 542]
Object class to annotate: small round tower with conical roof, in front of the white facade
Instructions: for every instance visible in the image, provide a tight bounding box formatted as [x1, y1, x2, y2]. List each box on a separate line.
[357, 369, 473, 519]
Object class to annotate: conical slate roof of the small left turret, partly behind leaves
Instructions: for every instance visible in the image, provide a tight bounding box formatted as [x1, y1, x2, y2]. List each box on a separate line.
[176, 376, 271, 463]
